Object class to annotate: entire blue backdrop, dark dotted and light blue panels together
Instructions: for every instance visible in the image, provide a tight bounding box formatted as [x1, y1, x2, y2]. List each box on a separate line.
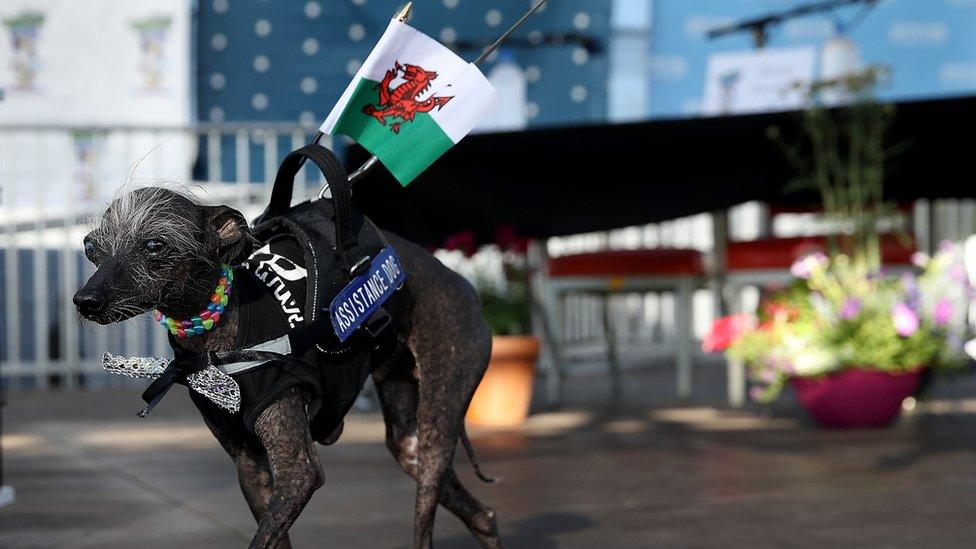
[196, 0, 976, 125]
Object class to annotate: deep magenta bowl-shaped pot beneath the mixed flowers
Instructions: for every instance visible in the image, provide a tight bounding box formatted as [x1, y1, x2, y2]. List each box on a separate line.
[790, 368, 923, 428]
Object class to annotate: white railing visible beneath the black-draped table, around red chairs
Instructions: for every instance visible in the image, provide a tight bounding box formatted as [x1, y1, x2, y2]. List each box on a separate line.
[548, 199, 976, 367]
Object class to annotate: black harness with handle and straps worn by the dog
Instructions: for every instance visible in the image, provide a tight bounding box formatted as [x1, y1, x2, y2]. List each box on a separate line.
[139, 144, 395, 440]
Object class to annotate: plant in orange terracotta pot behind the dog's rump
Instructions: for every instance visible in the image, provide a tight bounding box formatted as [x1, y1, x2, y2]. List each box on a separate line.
[437, 227, 539, 427]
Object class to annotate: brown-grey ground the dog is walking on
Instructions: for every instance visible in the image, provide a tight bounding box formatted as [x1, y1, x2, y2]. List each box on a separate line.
[0, 365, 976, 549]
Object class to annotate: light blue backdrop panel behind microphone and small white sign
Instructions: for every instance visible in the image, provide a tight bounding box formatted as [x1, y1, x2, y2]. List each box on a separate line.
[648, 0, 976, 117]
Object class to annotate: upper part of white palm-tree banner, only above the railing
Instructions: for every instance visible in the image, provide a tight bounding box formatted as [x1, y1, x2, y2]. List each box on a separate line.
[0, 0, 191, 126]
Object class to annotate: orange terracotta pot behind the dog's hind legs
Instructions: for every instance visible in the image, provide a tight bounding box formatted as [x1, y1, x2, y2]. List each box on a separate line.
[466, 336, 539, 427]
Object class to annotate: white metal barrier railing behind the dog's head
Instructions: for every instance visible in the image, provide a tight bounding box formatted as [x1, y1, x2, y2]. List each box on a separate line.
[0, 124, 331, 388]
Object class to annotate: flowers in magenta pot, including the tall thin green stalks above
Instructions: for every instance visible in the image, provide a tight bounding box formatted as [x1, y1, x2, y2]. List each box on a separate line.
[704, 68, 973, 427]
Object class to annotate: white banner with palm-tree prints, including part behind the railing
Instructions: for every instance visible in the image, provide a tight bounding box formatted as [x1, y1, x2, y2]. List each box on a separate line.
[0, 0, 195, 215]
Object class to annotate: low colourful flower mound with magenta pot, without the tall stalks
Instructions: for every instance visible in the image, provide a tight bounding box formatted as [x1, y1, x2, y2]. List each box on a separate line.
[705, 243, 973, 427]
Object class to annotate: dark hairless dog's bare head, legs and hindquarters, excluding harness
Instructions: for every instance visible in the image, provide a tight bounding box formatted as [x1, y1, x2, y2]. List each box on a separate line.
[74, 187, 502, 548]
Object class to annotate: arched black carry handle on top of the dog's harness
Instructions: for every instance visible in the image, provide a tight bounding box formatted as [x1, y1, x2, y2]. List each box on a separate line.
[256, 143, 355, 271]
